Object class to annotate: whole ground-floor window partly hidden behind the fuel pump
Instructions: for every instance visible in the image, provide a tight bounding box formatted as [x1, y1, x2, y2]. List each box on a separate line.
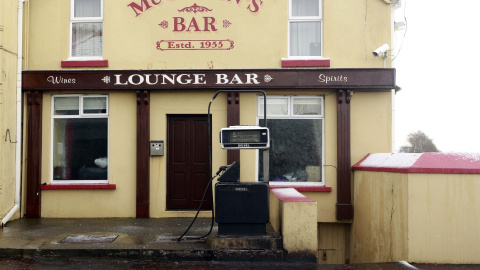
[257, 96, 324, 184]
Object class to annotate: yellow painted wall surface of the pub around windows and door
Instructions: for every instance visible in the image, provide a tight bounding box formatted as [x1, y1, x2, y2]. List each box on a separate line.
[21, 0, 392, 223]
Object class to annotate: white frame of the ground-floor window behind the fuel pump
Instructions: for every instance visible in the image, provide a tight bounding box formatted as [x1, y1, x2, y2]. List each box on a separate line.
[255, 95, 325, 186]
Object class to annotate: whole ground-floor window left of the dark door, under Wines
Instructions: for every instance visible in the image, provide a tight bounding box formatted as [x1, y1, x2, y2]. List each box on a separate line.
[52, 95, 108, 183]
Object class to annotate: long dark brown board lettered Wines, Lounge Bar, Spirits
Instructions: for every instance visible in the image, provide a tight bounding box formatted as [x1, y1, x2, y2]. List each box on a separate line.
[22, 68, 395, 91]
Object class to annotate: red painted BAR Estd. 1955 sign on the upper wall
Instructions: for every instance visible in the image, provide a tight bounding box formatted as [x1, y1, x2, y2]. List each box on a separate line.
[125, 0, 264, 52]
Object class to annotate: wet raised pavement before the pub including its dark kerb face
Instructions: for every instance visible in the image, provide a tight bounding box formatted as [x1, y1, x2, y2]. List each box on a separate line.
[0, 218, 287, 261]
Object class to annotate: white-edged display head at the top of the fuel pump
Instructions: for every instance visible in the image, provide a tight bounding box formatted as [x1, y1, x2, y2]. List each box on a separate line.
[220, 126, 270, 149]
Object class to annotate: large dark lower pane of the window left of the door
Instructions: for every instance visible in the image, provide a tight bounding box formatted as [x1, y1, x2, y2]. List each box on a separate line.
[53, 118, 108, 180]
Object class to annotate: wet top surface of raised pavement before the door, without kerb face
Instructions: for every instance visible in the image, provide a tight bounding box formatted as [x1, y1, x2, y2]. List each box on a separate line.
[0, 218, 216, 250]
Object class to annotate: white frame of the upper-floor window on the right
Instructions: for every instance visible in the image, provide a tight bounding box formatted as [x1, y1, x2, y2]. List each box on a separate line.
[285, 0, 325, 60]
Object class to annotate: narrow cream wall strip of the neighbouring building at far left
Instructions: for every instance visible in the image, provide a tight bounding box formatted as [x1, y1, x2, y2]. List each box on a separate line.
[0, 0, 23, 227]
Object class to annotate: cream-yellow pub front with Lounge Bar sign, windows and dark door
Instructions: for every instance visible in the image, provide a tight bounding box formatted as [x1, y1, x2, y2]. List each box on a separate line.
[6, 0, 395, 262]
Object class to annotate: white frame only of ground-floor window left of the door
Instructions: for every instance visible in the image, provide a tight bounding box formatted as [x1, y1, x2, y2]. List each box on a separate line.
[50, 94, 110, 185]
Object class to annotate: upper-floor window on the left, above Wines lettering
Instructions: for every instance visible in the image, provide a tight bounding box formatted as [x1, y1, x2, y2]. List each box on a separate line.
[70, 0, 103, 59]
